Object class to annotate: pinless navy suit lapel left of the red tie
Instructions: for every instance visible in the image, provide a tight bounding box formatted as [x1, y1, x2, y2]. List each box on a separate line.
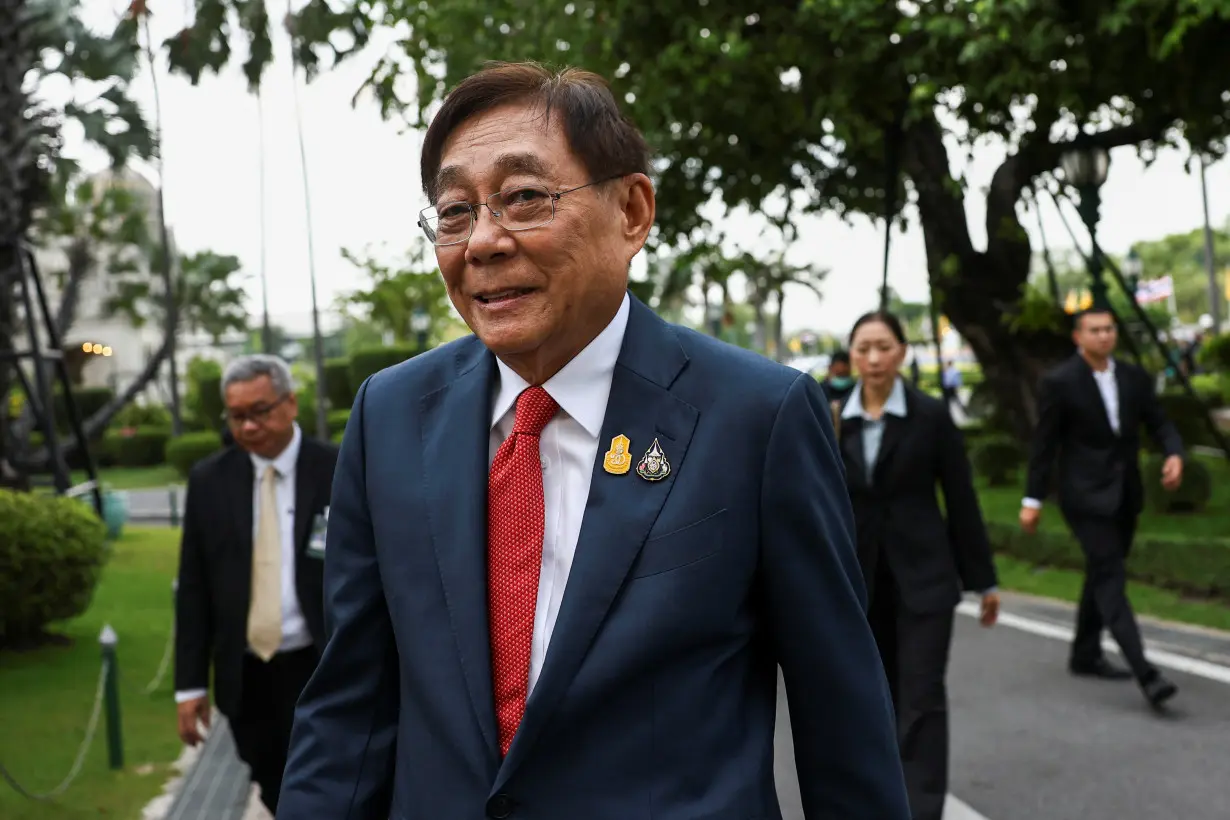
[422, 341, 499, 760]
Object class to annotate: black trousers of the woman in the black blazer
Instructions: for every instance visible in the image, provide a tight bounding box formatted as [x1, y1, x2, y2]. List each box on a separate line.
[867, 561, 956, 820]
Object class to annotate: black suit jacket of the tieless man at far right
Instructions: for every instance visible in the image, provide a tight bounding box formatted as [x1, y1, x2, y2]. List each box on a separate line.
[1026, 355, 1183, 515]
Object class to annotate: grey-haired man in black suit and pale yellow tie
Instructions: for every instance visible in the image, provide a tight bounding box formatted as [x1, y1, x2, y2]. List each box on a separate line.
[175, 355, 337, 811]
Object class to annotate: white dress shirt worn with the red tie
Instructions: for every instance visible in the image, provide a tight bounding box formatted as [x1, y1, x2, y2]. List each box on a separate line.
[490, 295, 630, 692]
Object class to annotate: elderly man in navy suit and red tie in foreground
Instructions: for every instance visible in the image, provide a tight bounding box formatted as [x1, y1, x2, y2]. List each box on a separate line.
[279, 64, 909, 820]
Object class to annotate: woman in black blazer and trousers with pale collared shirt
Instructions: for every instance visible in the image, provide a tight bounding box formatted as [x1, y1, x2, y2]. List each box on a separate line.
[834, 312, 999, 820]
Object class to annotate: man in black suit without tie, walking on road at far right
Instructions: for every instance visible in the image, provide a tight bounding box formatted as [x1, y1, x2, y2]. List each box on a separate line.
[1021, 307, 1183, 706]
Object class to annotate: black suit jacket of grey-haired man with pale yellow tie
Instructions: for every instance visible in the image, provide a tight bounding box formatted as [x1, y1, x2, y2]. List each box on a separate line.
[175, 436, 337, 716]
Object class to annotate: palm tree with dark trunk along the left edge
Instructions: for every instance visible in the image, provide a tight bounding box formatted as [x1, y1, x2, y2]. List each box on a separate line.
[0, 0, 154, 483]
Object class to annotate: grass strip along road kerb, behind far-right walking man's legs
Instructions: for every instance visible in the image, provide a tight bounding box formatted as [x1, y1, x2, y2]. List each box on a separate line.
[995, 554, 1230, 632]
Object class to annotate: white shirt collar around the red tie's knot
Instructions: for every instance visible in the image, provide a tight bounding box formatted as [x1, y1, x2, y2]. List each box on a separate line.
[491, 294, 631, 438]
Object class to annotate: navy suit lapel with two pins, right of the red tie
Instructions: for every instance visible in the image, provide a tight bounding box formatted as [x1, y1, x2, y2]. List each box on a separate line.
[494, 299, 699, 790]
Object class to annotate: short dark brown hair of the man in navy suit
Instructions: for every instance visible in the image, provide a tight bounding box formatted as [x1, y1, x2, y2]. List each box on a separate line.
[419, 63, 649, 204]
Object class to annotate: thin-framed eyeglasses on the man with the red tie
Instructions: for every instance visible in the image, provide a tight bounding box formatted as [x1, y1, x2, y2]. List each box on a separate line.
[418, 173, 625, 247]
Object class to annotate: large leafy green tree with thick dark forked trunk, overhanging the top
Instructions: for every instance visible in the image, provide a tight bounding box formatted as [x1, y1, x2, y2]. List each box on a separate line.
[170, 0, 1230, 434]
